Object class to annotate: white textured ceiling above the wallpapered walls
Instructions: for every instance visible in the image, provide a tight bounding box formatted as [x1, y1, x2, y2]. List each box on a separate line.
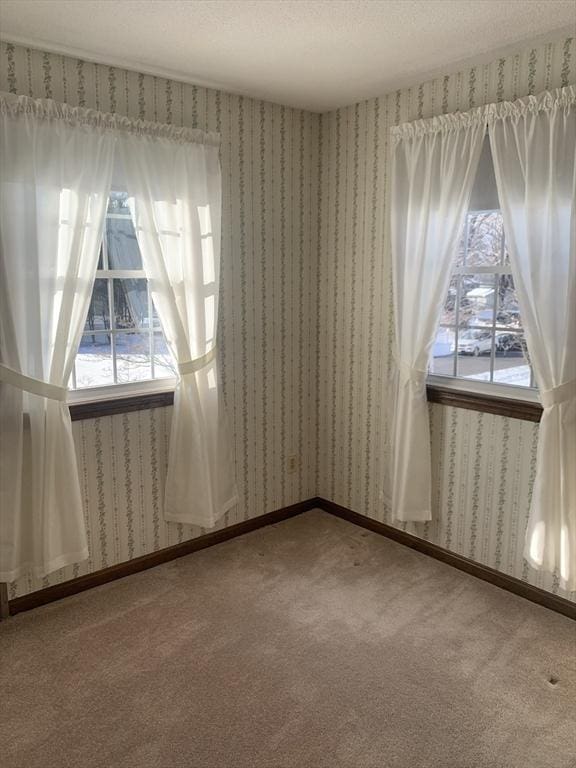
[0, 0, 576, 112]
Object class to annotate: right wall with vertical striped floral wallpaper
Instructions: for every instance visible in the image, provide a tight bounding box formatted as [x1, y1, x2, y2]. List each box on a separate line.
[317, 39, 576, 596]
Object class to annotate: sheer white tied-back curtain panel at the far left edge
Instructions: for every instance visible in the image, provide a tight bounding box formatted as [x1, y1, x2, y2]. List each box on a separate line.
[0, 94, 114, 581]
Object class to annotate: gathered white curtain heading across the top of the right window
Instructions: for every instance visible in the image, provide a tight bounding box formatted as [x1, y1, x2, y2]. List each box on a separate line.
[390, 85, 576, 142]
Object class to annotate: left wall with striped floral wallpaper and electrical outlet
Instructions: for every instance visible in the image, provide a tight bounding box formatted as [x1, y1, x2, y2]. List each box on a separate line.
[0, 43, 319, 597]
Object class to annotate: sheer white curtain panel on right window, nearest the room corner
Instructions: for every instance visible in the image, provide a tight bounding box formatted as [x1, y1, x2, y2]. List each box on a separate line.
[390, 109, 486, 521]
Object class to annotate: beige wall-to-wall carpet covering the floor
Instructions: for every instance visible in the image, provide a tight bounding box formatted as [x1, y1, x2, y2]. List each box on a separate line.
[0, 511, 576, 768]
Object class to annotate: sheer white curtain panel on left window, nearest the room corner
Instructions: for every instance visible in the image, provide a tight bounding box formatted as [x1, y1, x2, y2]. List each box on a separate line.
[118, 131, 238, 528]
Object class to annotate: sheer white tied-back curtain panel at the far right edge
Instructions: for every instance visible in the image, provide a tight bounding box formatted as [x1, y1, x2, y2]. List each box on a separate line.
[489, 86, 576, 590]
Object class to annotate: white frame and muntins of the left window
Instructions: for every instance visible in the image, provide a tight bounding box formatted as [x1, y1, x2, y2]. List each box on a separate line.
[67, 198, 178, 403]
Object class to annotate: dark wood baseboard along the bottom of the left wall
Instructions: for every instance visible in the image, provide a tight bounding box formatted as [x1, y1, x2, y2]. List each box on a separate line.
[8, 499, 314, 616]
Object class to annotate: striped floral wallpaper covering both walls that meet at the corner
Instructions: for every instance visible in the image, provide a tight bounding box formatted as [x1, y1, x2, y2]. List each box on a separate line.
[0, 34, 576, 597]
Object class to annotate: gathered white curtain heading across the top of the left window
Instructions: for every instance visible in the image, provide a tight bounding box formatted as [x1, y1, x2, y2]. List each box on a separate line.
[0, 91, 220, 147]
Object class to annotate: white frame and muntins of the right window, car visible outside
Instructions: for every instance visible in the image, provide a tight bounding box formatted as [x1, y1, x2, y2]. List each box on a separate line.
[427, 208, 539, 402]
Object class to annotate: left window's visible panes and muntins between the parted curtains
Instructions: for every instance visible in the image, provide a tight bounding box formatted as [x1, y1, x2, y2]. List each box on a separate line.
[71, 192, 176, 391]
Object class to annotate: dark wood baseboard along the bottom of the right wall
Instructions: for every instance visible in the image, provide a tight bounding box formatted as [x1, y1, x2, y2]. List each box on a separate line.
[313, 498, 576, 620]
